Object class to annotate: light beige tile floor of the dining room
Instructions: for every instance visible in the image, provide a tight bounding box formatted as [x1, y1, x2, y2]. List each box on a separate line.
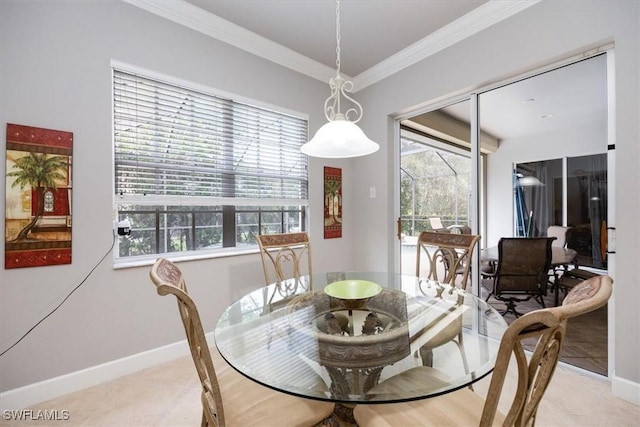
[0, 350, 640, 427]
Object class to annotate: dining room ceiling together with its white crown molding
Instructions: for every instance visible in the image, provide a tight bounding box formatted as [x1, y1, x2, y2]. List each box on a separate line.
[129, 0, 540, 88]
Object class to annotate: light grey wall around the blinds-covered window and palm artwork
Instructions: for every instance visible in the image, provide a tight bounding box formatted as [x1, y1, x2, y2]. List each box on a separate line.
[0, 1, 354, 400]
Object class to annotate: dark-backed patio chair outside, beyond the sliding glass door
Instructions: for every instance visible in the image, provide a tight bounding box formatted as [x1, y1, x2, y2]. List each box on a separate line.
[483, 237, 555, 317]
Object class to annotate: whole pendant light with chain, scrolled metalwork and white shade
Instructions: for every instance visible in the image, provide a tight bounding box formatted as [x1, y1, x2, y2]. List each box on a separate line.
[300, 0, 380, 158]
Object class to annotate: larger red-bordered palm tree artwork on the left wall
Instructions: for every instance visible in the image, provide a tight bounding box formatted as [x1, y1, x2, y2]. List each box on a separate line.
[4, 123, 73, 269]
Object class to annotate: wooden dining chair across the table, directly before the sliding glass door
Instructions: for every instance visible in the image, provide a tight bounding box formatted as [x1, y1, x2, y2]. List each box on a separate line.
[416, 231, 480, 372]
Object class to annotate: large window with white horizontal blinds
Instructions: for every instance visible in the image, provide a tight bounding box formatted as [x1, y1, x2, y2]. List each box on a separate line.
[113, 69, 308, 259]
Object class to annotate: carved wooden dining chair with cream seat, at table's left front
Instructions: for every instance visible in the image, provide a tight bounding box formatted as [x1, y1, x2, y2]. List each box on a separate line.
[149, 258, 334, 427]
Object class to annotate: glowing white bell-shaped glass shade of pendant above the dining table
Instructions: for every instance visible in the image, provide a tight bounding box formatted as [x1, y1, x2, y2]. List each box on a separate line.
[300, 119, 380, 159]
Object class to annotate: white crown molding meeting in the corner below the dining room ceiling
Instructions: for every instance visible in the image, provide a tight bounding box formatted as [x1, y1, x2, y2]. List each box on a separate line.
[123, 0, 542, 92]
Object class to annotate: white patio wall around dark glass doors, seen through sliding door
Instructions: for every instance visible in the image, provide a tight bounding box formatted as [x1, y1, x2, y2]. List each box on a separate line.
[482, 122, 607, 247]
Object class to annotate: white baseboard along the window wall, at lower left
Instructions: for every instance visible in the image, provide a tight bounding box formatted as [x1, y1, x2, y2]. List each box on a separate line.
[0, 333, 213, 411]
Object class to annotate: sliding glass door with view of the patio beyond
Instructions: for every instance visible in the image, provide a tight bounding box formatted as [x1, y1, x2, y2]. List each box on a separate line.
[397, 54, 615, 375]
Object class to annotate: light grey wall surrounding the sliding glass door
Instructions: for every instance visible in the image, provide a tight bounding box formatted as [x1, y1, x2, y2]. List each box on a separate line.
[353, 1, 640, 404]
